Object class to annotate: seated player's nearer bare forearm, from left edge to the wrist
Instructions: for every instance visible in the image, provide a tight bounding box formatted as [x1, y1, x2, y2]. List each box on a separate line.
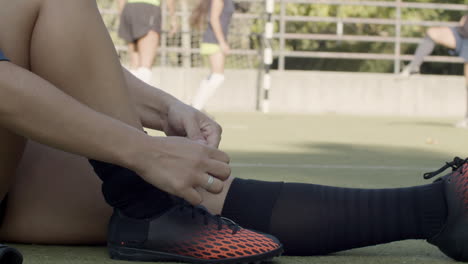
[0, 62, 147, 168]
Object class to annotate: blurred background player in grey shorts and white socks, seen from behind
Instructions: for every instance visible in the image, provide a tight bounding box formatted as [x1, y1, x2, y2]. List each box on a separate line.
[119, 0, 177, 83]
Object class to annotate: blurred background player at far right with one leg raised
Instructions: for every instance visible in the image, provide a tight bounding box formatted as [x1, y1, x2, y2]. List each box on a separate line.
[401, 15, 468, 128]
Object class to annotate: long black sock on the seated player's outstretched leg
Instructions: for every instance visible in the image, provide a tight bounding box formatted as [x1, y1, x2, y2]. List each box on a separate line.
[222, 179, 447, 256]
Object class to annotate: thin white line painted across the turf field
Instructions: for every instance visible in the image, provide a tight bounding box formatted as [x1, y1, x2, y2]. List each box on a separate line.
[231, 162, 438, 171]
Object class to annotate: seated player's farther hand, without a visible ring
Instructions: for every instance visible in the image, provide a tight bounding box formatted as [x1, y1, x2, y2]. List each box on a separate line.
[162, 102, 222, 148]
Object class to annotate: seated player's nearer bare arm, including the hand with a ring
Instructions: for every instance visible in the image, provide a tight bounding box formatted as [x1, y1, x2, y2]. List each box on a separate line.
[0, 62, 230, 204]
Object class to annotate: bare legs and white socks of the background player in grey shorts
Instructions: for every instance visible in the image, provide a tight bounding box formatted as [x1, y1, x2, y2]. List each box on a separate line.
[136, 30, 159, 83]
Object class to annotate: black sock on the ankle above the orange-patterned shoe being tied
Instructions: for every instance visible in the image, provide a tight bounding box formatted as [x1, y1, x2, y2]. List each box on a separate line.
[89, 160, 173, 218]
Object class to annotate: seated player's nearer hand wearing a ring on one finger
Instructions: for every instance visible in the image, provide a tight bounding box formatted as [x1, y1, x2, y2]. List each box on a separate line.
[135, 137, 231, 205]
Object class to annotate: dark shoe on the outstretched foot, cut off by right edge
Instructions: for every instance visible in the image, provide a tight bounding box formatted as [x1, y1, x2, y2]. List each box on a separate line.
[424, 157, 468, 261]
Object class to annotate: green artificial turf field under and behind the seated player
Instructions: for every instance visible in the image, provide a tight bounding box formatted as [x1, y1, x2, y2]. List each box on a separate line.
[11, 113, 468, 264]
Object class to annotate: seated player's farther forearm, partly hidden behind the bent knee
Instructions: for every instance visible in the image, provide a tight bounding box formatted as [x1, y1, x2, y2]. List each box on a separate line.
[124, 69, 181, 130]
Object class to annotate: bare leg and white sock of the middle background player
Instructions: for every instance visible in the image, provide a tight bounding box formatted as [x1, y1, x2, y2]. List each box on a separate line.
[192, 51, 226, 110]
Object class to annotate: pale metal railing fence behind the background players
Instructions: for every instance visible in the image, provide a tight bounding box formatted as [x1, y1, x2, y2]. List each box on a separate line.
[102, 0, 468, 73]
